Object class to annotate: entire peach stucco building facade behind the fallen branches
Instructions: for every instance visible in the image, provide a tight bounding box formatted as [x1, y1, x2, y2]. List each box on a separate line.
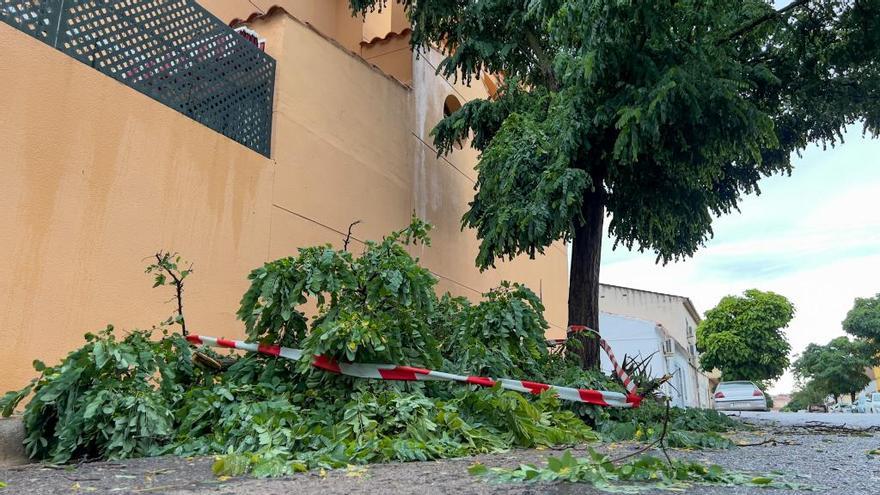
[0, 0, 568, 390]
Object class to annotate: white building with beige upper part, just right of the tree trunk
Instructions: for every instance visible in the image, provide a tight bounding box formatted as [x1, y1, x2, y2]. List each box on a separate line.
[599, 284, 718, 407]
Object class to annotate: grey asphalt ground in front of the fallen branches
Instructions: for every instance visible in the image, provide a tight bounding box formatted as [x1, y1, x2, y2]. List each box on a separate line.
[0, 427, 880, 495]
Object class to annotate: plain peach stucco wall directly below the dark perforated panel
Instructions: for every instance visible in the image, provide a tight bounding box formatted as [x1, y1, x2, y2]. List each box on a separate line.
[0, 23, 274, 390]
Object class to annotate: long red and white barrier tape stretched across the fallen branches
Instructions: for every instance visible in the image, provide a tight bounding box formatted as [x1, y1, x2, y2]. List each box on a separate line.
[186, 335, 642, 407]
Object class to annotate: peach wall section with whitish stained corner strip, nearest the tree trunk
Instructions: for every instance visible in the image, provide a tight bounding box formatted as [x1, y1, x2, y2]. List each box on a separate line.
[411, 48, 568, 338]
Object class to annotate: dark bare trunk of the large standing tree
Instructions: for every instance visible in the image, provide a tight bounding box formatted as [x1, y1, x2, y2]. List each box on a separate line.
[568, 186, 605, 369]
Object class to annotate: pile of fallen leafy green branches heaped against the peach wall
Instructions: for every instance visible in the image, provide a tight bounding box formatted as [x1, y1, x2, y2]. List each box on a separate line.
[0, 220, 597, 475]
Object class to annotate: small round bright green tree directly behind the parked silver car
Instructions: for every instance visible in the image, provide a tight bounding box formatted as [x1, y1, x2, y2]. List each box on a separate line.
[697, 289, 794, 382]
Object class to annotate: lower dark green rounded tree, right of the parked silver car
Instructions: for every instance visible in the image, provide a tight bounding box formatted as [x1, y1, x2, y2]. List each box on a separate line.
[792, 337, 871, 401]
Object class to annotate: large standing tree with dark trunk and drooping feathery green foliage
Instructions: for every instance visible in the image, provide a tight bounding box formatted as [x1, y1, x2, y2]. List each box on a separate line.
[350, 0, 880, 367]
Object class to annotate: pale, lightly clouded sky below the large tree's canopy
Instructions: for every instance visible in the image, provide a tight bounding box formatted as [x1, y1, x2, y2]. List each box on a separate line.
[601, 126, 880, 393]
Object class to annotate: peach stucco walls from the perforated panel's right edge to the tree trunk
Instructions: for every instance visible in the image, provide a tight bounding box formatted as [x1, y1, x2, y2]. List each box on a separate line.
[253, 15, 568, 337]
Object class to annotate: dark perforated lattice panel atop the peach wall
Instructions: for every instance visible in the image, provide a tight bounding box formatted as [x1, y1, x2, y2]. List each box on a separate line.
[0, 0, 275, 156]
